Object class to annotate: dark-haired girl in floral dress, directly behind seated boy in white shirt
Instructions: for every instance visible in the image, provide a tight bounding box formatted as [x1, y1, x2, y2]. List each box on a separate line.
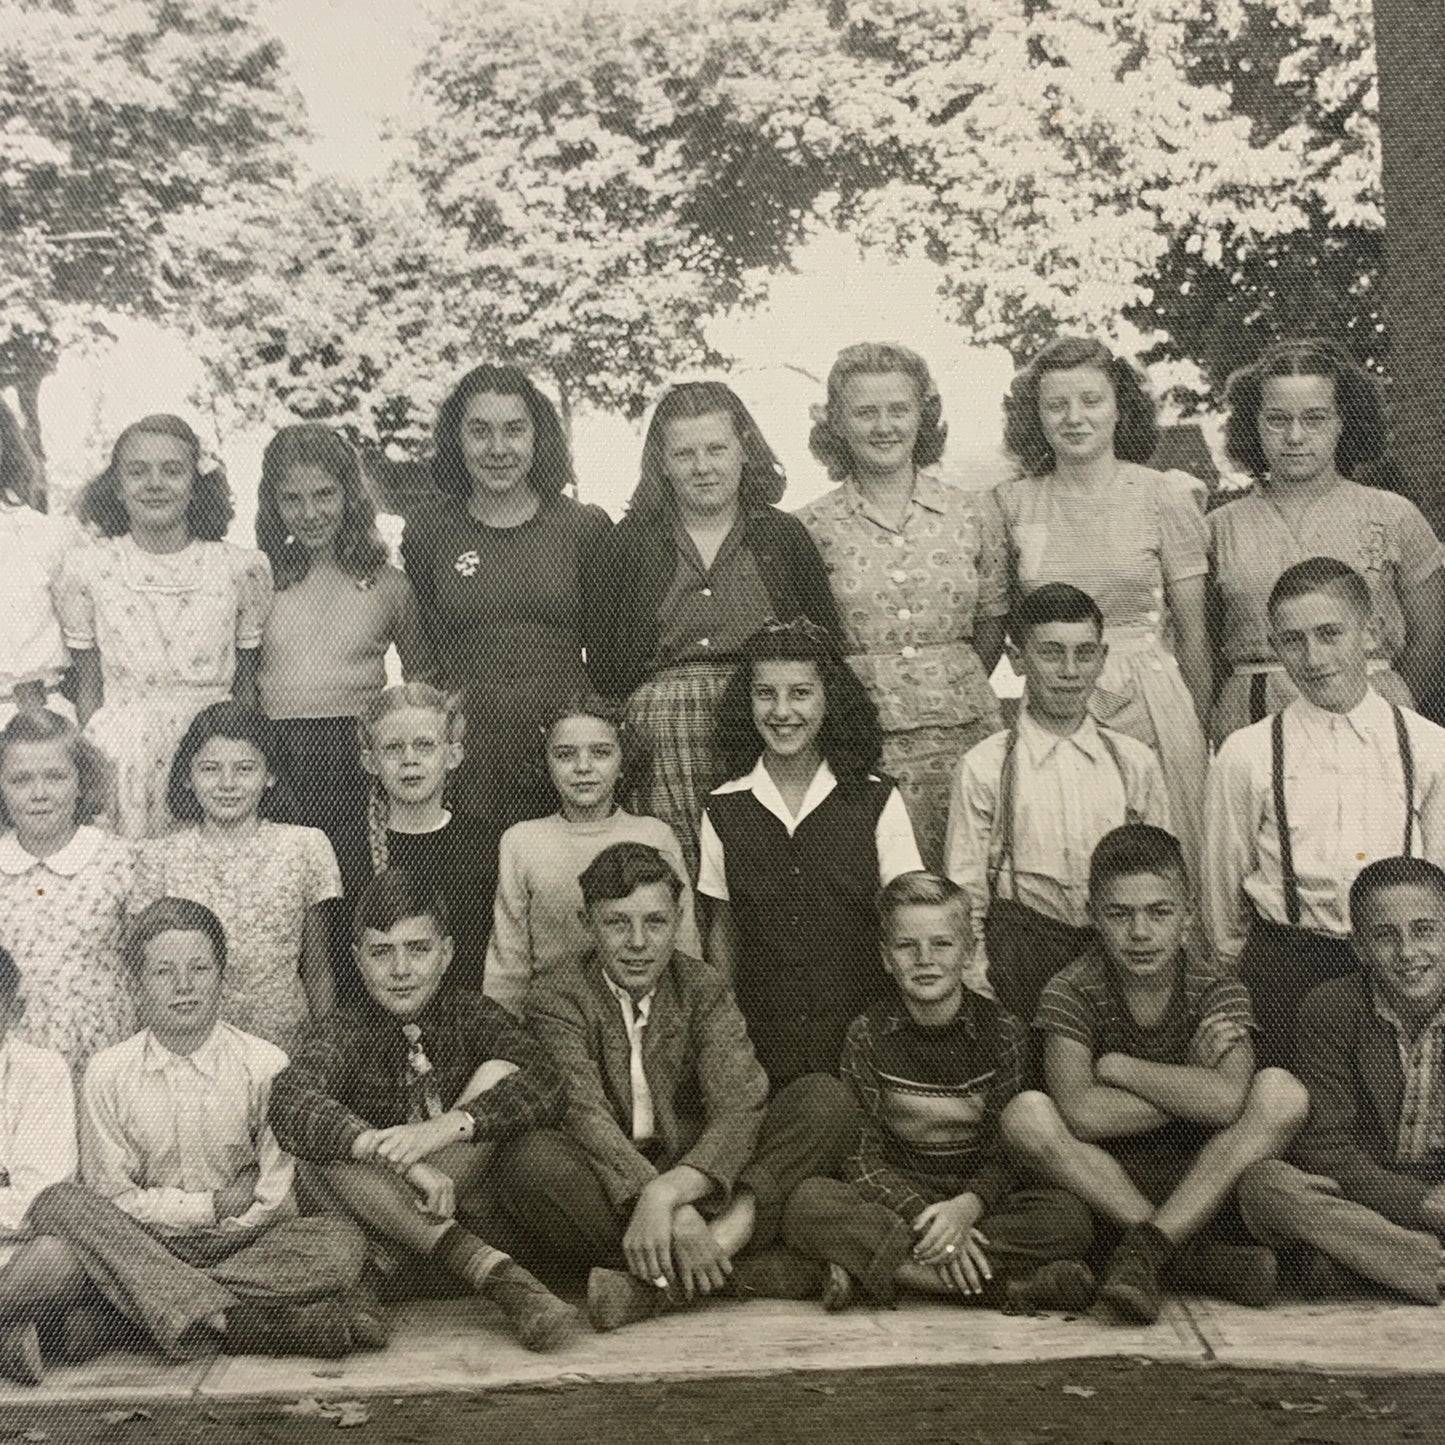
[131, 702, 341, 1051]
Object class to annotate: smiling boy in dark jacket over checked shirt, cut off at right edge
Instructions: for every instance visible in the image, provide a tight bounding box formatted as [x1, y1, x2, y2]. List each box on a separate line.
[1240, 858, 1445, 1305]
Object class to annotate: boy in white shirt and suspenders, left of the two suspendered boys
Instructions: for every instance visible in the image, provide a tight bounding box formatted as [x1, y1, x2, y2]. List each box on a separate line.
[944, 582, 1169, 1023]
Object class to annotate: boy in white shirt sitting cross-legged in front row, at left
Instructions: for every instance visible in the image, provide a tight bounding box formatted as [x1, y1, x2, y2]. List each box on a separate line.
[0, 897, 384, 1383]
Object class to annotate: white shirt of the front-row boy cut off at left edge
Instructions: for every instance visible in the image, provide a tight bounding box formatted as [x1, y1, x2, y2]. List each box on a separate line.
[0, 1038, 77, 1237]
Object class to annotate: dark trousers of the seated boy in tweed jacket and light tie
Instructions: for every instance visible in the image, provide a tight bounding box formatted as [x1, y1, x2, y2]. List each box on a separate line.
[497, 1074, 858, 1277]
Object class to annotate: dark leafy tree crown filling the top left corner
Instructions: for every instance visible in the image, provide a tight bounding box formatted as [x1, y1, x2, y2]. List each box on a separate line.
[0, 0, 299, 445]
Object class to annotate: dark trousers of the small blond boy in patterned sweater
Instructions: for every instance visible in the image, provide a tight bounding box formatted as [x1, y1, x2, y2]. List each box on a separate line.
[783, 1179, 1094, 1305]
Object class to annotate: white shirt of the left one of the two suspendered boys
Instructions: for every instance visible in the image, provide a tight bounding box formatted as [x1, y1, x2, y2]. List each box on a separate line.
[944, 708, 1169, 958]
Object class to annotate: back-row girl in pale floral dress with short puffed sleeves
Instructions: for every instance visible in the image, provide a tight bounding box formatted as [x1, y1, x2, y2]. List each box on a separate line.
[58, 415, 272, 838]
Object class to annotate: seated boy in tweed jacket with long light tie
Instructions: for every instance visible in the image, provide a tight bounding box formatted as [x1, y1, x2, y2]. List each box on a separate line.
[512, 842, 855, 1329]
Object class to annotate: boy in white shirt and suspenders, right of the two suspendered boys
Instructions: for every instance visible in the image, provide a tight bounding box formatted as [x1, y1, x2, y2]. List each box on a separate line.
[1202, 558, 1445, 1068]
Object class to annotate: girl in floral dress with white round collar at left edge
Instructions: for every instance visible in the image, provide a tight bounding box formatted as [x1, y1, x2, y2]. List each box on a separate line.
[0, 708, 134, 1078]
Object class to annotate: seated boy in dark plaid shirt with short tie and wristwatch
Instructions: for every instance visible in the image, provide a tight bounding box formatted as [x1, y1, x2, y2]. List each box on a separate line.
[270, 868, 577, 1350]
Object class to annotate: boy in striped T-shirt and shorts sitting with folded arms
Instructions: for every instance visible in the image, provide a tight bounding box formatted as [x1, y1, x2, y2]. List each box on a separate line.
[1003, 824, 1308, 1322]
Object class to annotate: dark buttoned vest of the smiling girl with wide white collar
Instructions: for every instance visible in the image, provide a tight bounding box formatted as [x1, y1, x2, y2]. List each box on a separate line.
[708, 779, 893, 1092]
